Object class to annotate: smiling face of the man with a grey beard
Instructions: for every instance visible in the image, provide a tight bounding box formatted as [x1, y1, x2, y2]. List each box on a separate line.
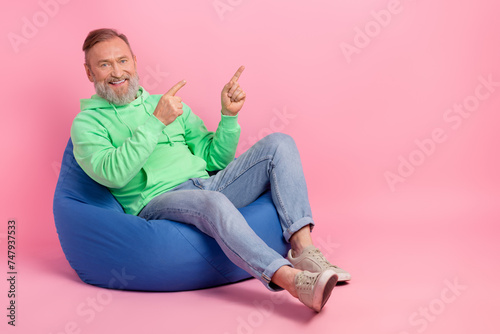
[85, 37, 139, 105]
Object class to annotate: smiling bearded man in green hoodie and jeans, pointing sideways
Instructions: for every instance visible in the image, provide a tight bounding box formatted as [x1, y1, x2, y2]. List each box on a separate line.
[71, 29, 350, 312]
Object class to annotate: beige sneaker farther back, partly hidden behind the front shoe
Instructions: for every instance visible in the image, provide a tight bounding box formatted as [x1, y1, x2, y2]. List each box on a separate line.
[287, 245, 351, 282]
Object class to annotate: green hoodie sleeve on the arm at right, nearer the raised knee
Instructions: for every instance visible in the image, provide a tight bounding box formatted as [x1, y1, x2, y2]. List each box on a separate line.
[183, 106, 241, 171]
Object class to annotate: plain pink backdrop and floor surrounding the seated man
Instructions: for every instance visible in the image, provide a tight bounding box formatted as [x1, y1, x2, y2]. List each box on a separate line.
[0, 0, 500, 334]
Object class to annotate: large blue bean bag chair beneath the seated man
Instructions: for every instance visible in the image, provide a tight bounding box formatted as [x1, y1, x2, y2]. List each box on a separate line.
[53, 139, 289, 291]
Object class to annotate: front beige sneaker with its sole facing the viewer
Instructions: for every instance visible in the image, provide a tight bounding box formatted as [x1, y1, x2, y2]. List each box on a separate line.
[295, 269, 338, 312]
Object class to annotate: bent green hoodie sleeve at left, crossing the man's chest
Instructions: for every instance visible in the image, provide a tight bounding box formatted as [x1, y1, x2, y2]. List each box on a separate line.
[71, 113, 165, 188]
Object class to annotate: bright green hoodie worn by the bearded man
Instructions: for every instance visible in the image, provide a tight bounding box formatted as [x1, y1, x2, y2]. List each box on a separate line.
[71, 87, 241, 215]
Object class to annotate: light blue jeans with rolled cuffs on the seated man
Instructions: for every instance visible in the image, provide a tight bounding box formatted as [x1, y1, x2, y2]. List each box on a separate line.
[139, 133, 314, 290]
